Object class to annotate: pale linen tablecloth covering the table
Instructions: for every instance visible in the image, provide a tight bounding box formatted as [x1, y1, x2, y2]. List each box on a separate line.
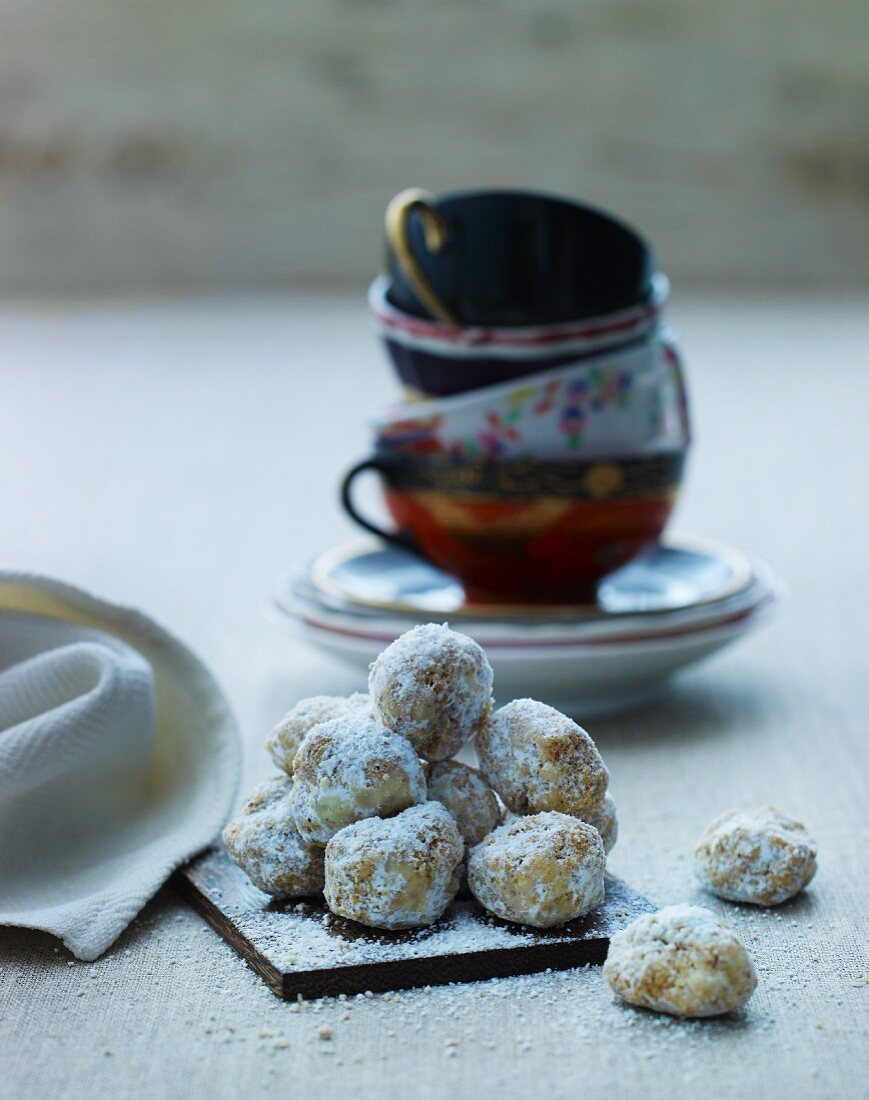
[0, 293, 869, 1100]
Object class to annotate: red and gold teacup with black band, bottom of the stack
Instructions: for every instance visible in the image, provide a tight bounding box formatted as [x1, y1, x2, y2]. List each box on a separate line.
[341, 451, 685, 603]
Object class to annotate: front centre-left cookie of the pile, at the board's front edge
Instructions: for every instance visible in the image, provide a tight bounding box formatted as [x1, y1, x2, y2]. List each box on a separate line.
[325, 802, 464, 930]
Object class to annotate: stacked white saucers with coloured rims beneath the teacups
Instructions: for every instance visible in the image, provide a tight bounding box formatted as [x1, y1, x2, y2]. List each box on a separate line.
[274, 536, 782, 716]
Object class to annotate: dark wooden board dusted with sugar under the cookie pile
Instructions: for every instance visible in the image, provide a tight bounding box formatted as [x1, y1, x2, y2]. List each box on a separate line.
[173, 848, 655, 998]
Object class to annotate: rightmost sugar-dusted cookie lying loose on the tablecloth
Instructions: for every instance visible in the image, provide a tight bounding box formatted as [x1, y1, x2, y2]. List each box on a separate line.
[694, 806, 817, 905]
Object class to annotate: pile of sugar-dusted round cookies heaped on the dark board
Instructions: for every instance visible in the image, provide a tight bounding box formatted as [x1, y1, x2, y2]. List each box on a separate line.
[223, 624, 617, 930]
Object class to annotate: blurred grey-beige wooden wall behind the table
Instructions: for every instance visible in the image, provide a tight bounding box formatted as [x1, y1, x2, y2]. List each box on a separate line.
[0, 0, 869, 294]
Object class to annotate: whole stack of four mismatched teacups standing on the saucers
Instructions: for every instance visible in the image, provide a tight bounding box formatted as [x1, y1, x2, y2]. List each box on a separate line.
[342, 190, 689, 603]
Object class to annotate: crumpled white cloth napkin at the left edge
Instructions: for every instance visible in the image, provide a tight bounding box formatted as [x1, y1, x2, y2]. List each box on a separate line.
[0, 572, 241, 959]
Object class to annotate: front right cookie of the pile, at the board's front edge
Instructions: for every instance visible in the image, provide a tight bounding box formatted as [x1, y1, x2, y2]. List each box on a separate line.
[468, 812, 606, 928]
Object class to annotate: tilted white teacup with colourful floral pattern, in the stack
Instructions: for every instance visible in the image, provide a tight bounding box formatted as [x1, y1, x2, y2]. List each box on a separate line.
[372, 334, 690, 462]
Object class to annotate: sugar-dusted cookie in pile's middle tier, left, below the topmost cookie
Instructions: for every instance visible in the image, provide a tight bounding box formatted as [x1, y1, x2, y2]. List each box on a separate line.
[290, 717, 426, 844]
